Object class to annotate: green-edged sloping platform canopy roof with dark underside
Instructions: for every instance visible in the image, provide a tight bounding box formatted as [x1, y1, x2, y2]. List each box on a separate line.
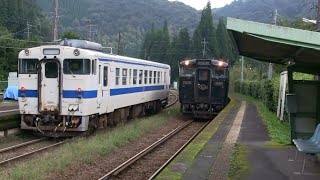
[227, 18, 320, 72]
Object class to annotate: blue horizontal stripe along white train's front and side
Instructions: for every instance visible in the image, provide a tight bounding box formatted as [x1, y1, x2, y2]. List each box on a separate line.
[19, 85, 165, 99]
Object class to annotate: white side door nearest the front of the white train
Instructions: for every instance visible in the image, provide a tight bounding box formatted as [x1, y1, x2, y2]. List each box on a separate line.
[98, 64, 110, 113]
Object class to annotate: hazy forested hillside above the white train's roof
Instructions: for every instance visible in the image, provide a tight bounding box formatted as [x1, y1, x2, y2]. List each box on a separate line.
[38, 0, 200, 56]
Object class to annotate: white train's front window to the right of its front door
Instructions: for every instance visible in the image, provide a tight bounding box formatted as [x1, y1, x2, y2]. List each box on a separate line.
[63, 59, 91, 75]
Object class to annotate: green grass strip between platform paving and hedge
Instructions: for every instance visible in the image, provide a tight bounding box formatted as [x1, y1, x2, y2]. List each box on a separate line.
[236, 93, 290, 145]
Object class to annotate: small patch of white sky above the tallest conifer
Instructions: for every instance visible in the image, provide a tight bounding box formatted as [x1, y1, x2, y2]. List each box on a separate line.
[170, 0, 234, 10]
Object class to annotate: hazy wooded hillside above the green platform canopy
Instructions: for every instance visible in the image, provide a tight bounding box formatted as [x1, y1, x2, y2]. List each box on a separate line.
[214, 0, 316, 23]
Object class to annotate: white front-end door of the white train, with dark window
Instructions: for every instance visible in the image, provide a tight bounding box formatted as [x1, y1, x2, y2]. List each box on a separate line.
[38, 59, 61, 113]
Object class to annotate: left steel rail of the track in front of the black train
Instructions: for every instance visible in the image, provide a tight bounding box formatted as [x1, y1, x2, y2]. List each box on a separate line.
[99, 120, 193, 180]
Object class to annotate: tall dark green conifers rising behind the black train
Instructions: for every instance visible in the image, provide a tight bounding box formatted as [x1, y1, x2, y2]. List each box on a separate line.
[140, 3, 236, 81]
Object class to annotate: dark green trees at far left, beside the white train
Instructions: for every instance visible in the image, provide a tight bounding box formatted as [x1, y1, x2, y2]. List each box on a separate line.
[0, 0, 50, 80]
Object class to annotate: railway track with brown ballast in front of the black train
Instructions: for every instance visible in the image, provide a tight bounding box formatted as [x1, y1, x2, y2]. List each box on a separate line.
[99, 120, 209, 180]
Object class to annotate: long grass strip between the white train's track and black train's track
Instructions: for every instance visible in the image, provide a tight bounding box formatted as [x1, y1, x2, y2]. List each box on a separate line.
[0, 105, 180, 180]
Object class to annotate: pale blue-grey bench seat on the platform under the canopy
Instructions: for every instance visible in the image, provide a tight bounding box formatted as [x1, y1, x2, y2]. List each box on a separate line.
[292, 123, 320, 174]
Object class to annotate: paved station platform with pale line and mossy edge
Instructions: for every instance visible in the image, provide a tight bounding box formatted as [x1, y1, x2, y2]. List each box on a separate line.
[156, 97, 320, 180]
